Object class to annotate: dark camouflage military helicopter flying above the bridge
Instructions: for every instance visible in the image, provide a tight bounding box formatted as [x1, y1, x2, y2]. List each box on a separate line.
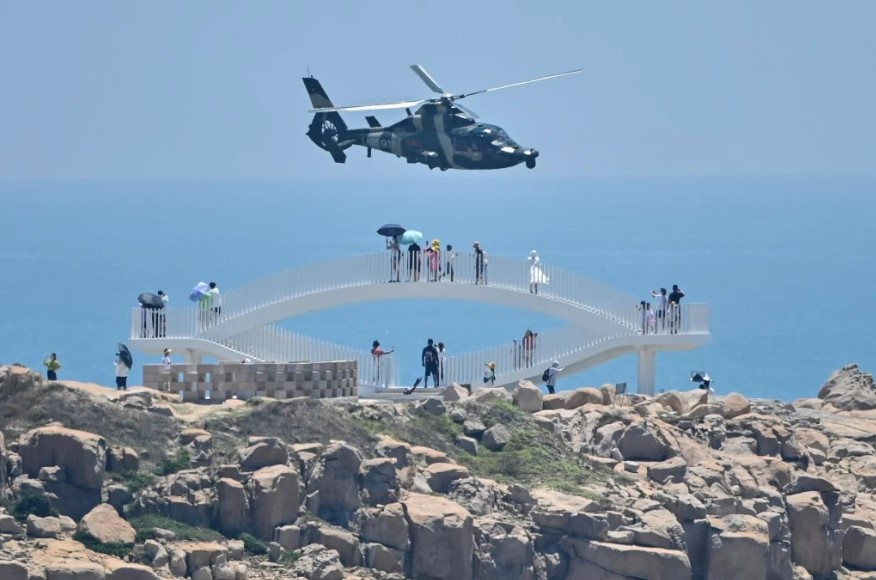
[303, 64, 582, 171]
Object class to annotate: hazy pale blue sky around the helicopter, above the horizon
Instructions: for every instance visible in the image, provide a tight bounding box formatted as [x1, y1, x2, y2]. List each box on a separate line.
[0, 0, 876, 180]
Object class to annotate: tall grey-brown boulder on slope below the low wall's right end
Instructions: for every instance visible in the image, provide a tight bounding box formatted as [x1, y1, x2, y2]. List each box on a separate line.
[308, 441, 362, 521]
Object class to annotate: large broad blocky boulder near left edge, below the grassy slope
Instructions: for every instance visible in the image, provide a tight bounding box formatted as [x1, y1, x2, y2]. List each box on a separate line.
[19, 425, 106, 490]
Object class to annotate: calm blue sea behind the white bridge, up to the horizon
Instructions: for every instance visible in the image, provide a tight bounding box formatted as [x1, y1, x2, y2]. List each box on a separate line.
[0, 178, 876, 399]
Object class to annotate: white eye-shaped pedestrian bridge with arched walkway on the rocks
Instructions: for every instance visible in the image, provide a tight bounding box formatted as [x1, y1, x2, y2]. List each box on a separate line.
[130, 252, 710, 395]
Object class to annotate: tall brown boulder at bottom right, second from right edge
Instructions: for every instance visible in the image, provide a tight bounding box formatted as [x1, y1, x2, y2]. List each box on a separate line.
[785, 491, 842, 577]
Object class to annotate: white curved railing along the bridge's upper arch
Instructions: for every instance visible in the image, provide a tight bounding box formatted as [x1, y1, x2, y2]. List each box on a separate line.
[216, 252, 638, 327]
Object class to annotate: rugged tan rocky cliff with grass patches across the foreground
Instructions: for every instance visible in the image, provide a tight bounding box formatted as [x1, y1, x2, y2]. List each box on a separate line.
[0, 366, 876, 580]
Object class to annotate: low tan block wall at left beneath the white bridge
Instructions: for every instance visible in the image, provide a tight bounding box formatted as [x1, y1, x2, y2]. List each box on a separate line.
[143, 361, 359, 402]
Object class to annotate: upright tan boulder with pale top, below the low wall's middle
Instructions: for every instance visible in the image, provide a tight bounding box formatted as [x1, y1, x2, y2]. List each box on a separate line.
[246, 465, 299, 540]
